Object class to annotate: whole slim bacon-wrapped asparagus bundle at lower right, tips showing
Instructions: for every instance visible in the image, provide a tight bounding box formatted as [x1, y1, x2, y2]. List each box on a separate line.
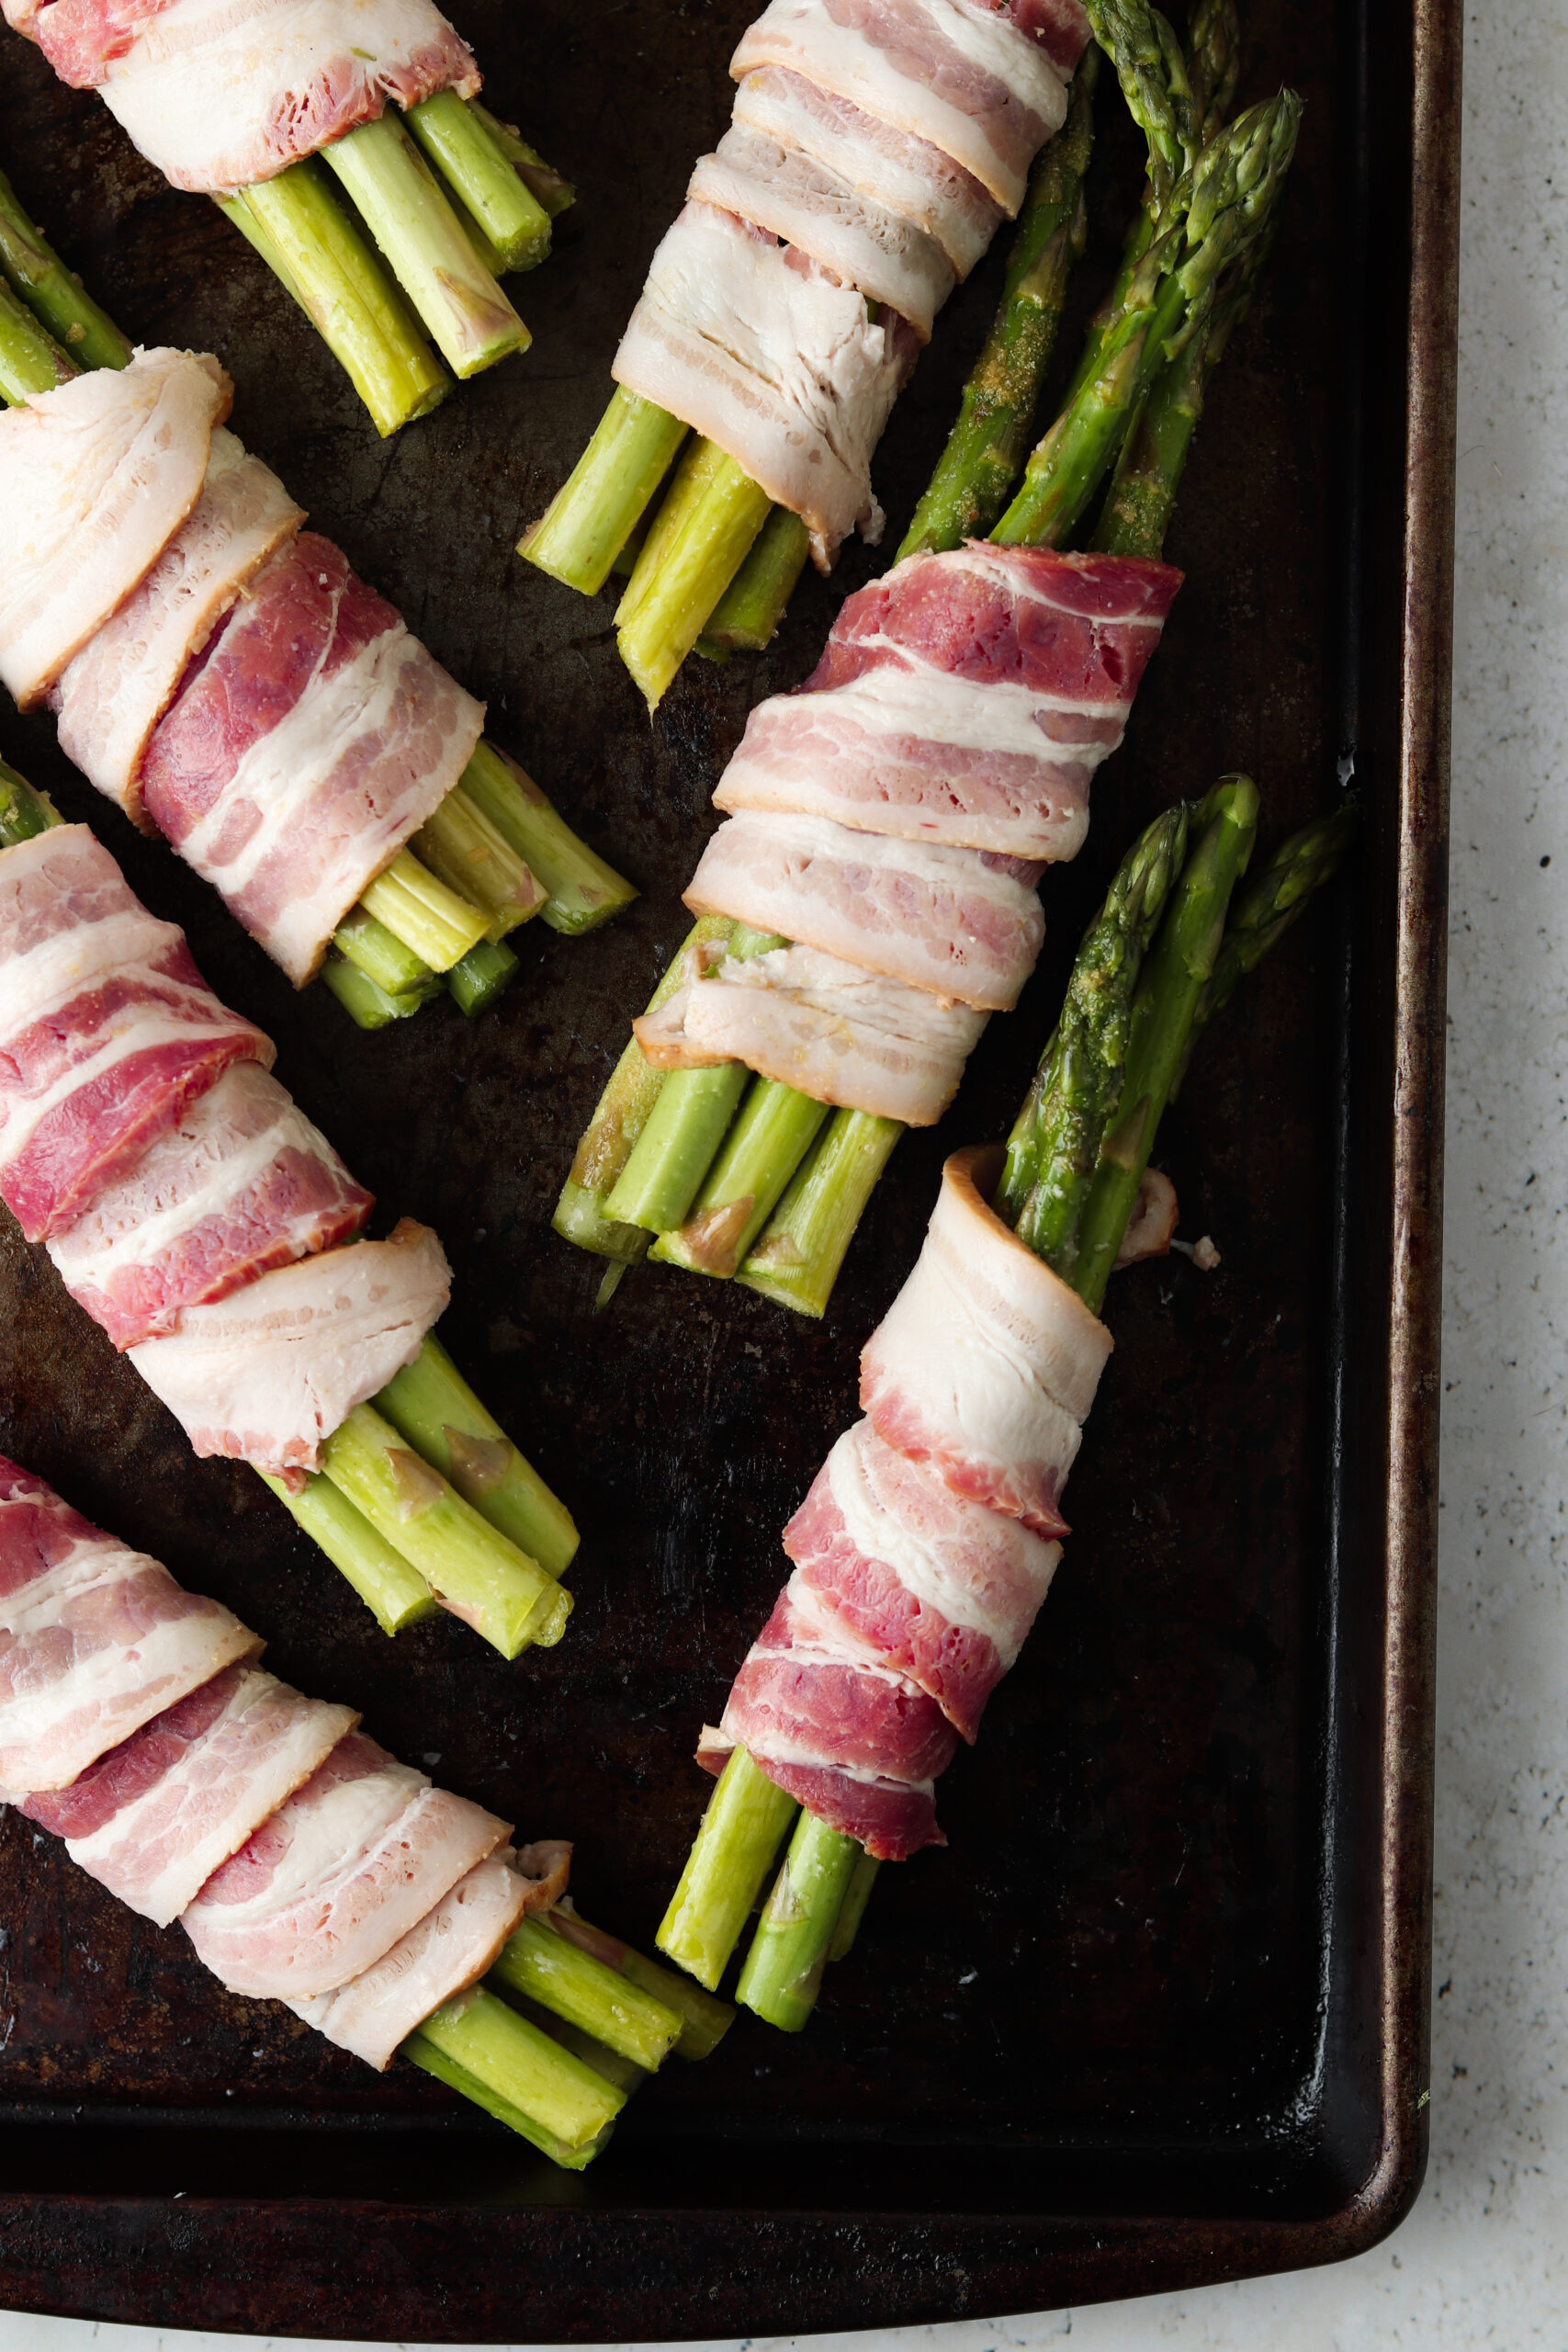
[659, 776, 1354, 2030]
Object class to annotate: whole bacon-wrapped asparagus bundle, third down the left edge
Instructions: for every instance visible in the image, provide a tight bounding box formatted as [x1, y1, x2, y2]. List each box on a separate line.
[0, 767, 579, 1658]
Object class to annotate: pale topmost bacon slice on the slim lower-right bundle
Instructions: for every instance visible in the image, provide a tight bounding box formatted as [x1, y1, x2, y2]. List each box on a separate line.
[861, 1148, 1112, 1536]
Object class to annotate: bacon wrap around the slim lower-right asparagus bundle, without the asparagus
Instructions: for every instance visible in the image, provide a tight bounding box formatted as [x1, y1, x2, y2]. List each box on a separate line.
[698, 1150, 1146, 1860]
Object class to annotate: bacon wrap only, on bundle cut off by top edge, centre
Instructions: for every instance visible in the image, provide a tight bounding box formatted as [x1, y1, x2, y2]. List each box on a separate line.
[611, 0, 1089, 571]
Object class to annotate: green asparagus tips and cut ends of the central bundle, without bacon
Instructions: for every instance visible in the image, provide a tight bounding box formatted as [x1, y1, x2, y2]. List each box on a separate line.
[555, 0, 1300, 1315]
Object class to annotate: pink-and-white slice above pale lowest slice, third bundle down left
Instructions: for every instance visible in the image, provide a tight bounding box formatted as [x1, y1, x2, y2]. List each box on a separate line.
[50, 1063, 374, 1348]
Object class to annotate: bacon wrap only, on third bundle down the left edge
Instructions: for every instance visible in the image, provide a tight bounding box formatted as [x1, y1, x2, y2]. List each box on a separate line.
[0, 826, 451, 1477]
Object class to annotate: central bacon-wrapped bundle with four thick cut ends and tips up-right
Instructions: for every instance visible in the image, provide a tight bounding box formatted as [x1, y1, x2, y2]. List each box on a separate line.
[555, 37, 1300, 1315]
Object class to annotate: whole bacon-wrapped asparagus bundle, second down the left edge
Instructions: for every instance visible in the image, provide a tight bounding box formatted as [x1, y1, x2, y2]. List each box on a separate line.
[0, 207, 635, 1028]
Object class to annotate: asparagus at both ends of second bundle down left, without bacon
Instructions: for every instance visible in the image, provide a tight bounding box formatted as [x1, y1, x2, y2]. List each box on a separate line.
[0, 163, 637, 1028]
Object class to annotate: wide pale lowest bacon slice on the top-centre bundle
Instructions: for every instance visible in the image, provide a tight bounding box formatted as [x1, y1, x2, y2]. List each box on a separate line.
[611, 205, 919, 571]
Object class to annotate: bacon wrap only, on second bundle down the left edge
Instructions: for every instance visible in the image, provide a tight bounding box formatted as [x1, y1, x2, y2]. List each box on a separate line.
[0, 343, 484, 986]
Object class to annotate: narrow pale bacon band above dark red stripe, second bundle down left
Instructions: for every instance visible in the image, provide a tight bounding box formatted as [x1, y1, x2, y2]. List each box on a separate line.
[51, 433, 306, 828]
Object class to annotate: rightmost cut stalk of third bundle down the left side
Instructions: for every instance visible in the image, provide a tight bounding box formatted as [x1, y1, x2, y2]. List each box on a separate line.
[374, 1331, 581, 1576]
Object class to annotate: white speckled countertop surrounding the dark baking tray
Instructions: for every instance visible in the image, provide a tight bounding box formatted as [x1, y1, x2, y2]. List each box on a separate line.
[0, 0, 1568, 2352]
